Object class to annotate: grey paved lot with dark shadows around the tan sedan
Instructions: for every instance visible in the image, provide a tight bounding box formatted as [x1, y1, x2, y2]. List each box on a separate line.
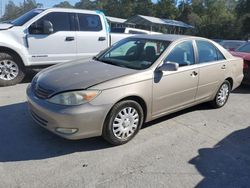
[0, 75, 250, 188]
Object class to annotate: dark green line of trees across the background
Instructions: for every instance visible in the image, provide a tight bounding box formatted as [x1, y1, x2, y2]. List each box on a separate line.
[1, 0, 250, 39]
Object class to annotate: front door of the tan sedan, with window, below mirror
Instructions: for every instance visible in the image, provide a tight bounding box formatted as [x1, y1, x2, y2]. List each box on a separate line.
[152, 41, 199, 117]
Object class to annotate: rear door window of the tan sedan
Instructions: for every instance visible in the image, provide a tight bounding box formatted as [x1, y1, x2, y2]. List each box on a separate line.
[196, 41, 225, 63]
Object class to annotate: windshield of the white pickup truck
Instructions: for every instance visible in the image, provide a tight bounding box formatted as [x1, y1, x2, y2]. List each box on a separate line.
[10, 9, 44, 26]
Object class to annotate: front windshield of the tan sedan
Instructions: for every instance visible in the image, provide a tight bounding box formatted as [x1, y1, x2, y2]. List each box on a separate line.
[97, 38, 170, 70]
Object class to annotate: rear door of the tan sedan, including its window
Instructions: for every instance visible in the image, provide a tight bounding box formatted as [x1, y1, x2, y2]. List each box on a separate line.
[196, 40, 227, 101]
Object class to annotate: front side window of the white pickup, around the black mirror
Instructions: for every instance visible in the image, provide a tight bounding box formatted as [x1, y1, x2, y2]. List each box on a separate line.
[30, 12, 72, 34]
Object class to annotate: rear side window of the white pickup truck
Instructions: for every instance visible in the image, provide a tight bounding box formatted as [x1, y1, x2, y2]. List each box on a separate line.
[78, 14, 102, 31]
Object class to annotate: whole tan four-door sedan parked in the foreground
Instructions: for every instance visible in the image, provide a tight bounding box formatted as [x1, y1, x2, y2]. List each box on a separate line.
[27, 35, 243, 145]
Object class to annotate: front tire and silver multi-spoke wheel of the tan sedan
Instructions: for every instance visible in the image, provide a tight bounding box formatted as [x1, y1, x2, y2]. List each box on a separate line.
[102, 100, 144, 145]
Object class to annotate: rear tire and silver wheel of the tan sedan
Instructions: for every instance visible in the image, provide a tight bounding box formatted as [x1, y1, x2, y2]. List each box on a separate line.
[211, 80, 231, 108]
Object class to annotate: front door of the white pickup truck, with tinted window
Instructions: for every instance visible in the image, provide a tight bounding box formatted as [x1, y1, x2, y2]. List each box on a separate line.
[27, 12, 77, 65]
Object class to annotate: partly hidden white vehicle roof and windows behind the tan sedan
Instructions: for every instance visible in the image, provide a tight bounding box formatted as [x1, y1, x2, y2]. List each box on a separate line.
[111, 27, 162, 34]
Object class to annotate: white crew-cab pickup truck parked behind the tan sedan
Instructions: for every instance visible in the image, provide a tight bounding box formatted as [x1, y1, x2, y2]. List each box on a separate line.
[0, 8, 128, 86]
